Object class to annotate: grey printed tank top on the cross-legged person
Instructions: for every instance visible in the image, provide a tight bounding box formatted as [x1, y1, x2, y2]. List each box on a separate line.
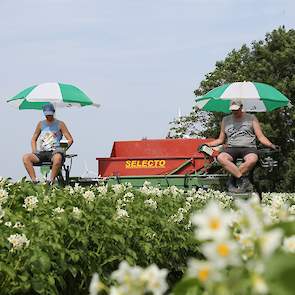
[223, 113, 256, 147]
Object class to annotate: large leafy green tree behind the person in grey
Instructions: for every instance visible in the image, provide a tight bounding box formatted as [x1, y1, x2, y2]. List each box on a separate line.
[171, 27, 295, 191]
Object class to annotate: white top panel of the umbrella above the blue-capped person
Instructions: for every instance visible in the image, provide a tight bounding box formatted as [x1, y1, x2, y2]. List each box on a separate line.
[26, 83, 62, 102]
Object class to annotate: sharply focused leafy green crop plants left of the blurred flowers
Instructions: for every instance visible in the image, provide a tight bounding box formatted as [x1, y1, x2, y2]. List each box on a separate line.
[0, 181, 205, 294]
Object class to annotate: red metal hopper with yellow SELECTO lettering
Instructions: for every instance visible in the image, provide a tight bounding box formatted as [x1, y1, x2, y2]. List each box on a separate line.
[96, 139, 213, 177]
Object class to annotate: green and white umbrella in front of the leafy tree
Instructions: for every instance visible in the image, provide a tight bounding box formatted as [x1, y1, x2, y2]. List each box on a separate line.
[196, 82, 291, 113]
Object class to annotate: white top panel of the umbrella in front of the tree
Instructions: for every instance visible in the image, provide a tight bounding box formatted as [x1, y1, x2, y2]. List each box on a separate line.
[220, 82, 259, 99]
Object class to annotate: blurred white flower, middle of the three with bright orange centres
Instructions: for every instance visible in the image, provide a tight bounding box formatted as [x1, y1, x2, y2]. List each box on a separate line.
[201, 240, 240, 268]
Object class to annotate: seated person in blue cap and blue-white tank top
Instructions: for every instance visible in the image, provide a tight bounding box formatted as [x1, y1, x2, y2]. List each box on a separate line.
[23, 103, 73, 183]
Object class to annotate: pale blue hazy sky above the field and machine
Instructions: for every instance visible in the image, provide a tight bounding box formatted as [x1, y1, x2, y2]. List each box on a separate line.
[0, 0, 295, 179]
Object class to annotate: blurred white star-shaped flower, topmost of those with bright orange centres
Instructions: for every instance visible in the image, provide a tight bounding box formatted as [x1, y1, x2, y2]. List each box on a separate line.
[192, 202, 233, 240]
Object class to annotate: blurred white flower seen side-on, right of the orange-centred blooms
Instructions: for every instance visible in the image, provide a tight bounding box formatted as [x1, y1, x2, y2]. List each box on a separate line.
[259, 228, 283, 257]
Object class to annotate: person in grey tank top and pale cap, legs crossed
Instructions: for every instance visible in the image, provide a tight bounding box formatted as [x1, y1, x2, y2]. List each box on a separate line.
[208, 99, 277, 193]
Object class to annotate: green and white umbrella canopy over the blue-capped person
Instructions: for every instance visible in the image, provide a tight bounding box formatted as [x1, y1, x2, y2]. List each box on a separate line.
[7, 83, 99, 110]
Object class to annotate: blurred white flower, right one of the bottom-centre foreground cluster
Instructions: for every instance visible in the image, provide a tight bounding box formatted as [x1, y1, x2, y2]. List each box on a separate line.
[141, 264, 168, 295]
